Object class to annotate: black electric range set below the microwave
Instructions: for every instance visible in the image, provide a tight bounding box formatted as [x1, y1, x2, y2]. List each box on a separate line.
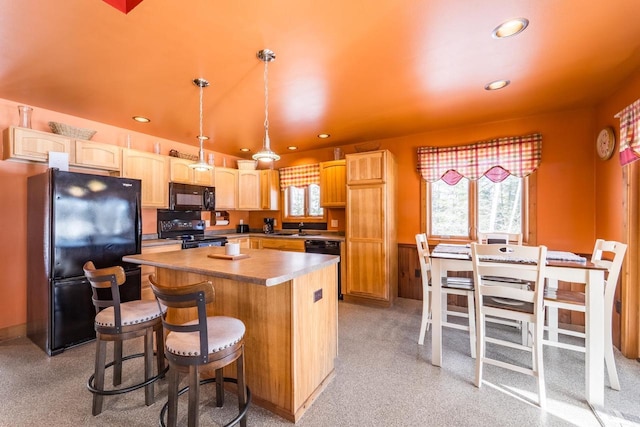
[158, 210, 227, 249]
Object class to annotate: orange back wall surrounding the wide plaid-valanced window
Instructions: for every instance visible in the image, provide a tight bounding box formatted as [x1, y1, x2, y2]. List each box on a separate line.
[278, 109, 595, 253]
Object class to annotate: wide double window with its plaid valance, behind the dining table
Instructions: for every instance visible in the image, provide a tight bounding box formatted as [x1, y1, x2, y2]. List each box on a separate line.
[418, 133, 542, 242]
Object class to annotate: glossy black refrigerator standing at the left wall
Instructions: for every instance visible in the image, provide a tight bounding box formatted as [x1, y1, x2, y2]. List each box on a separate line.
[27, 169, 142, 356]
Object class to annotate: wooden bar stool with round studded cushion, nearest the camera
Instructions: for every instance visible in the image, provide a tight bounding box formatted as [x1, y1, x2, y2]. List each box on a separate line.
[149, 274, 251, 427]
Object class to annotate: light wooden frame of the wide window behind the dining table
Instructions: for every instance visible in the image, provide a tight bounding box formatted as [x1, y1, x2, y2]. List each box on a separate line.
[420, 172, 537, 245]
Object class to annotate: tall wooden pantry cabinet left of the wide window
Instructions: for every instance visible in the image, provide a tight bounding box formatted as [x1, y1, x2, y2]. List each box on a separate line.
[344, 150, 398, 307]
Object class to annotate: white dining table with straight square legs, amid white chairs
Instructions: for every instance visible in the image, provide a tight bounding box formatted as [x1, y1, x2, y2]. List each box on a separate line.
[431, 244, 606, 406]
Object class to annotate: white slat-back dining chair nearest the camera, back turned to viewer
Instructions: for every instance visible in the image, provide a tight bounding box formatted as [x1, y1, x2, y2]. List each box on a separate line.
[471, 243, 547, 408]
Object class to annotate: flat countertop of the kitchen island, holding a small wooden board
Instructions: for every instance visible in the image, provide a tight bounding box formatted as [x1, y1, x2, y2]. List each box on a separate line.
[123, 246, 340, 286]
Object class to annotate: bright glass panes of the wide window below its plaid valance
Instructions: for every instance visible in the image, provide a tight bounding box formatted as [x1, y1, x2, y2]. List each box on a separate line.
[424, 175, 532, 240]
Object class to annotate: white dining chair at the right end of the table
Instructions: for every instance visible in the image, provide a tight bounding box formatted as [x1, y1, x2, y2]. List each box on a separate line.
[544, 239, 627, 390]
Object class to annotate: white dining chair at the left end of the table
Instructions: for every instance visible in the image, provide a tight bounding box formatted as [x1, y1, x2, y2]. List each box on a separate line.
[416, 233, 476, 357]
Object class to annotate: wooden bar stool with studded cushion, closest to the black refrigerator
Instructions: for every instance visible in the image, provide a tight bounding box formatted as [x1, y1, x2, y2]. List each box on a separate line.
[83, 261, 168, 415]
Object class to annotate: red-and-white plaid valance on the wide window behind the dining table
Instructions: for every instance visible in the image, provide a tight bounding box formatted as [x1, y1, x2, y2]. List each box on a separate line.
[418, 133, 542, 185]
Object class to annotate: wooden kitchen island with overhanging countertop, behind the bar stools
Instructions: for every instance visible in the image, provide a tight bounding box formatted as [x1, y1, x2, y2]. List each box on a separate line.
[123, 247, 339, 422]
